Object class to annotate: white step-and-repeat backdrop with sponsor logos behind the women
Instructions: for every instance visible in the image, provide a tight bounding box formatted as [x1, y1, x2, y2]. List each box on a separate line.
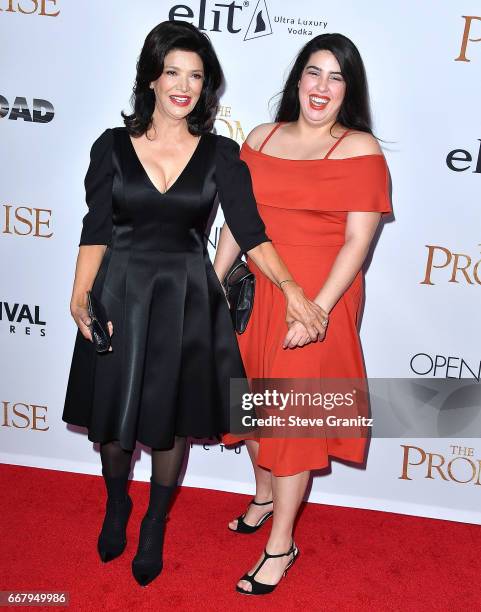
[0, 0, 481, 523]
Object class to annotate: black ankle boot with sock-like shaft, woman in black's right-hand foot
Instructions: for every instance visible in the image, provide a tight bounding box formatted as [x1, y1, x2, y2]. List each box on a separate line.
[132, 480, 176, 586]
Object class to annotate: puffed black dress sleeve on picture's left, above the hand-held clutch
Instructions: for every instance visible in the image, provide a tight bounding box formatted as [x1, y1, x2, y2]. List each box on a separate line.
[79, 129, 113, 246]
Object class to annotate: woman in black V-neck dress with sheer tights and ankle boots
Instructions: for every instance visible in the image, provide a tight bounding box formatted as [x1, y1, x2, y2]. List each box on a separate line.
[63, 22, 325, 585]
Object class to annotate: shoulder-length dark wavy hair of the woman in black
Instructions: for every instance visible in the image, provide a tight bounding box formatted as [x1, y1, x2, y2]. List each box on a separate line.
[122, 21, 223, 136]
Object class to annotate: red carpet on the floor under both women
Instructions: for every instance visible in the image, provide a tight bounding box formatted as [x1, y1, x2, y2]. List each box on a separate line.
[0, 465, 481, 612]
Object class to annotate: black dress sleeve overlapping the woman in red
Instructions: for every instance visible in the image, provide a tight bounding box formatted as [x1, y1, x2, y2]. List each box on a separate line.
[215, 136, 270, 253]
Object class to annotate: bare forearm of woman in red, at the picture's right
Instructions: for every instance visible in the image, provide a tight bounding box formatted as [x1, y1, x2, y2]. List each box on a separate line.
[314, 239, 369, 312]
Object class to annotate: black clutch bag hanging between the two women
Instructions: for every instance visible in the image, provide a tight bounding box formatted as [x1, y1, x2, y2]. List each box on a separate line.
[223, 259, 256, 334]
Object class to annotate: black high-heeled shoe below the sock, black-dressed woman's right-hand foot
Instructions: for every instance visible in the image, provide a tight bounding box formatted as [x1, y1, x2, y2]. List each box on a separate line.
[132, 514, 165, 586]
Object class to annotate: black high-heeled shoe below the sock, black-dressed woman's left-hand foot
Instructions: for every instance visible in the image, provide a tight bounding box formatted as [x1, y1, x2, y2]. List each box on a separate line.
[97, 495, 132, 563]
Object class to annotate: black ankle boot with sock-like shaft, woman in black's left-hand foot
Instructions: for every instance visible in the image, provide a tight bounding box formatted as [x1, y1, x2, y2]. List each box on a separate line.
[97, 476, 132, 563]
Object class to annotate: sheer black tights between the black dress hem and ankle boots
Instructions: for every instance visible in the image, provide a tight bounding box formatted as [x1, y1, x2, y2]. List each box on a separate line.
[100, 436, 187, 495]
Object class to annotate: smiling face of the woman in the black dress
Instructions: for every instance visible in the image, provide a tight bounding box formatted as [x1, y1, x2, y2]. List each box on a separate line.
[150, 49, 204, 119]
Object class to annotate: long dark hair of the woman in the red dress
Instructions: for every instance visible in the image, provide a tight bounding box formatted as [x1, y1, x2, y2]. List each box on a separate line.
[275, 34, 372, 134]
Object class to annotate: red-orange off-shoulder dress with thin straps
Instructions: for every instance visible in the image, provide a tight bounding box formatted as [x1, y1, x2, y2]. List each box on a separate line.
[224, 125, 391, 476]
